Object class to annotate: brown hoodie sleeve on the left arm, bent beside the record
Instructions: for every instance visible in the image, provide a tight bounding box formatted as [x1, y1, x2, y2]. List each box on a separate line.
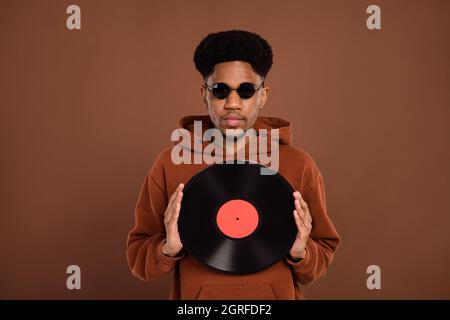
[127, 159, 185, 281]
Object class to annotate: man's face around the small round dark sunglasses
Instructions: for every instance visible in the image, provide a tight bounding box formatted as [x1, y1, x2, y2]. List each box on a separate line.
[201, 61, 269, 133]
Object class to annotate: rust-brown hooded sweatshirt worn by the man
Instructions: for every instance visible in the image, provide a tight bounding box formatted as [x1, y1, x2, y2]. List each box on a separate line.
[127, 115, 340, 299]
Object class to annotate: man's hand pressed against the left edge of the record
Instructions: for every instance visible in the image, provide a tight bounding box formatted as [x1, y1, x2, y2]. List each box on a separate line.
[162, 183, 184, 257]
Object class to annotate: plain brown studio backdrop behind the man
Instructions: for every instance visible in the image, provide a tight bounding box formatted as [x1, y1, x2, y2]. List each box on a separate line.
[0, 0, 450, 299]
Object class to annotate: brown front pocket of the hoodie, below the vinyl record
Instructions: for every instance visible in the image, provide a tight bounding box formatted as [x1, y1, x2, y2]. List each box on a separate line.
[197, 283, 276, 300]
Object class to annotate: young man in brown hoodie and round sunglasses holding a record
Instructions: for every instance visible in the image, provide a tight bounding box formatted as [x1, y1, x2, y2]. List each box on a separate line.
[127, 30, 340, 299]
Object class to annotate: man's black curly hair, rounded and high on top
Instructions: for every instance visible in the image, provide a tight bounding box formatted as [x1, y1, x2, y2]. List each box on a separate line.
[194, 30, 273, 79]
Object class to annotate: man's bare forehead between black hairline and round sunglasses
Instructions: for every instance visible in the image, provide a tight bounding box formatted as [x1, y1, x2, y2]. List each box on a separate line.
[208, 61, 261, 86]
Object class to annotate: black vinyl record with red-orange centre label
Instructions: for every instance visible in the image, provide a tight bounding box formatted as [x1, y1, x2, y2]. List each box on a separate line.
[178, 162, 297, 274]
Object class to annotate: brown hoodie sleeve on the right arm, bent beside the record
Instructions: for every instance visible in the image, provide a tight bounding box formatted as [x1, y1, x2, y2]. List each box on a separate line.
[285, 172, 341, 285]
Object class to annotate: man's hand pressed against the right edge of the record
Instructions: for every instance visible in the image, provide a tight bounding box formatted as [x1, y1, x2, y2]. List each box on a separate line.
[289, 191, 312, 259]
